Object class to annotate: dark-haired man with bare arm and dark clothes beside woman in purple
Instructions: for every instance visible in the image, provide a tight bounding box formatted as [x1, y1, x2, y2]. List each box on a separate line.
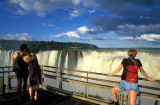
[12, 44, 29, 102]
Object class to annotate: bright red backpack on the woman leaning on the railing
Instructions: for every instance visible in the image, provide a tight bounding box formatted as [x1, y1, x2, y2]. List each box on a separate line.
[126, 62, 138, 83]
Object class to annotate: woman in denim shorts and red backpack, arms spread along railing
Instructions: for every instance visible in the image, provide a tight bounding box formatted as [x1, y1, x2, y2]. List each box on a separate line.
[108, 49, 155, 105]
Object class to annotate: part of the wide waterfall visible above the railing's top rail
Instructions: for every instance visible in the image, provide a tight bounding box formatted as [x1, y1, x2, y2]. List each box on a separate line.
[0, 50, 160, 80]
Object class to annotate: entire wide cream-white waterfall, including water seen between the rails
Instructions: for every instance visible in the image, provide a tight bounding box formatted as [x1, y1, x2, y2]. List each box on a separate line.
[0, 50, 160, 102]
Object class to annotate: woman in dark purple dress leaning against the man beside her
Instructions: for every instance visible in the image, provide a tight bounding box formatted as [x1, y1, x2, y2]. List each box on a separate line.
[24, 49, 41, 102]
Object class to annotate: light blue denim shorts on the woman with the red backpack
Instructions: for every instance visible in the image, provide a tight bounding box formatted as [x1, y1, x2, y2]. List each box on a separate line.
[118, 80, 140, 93]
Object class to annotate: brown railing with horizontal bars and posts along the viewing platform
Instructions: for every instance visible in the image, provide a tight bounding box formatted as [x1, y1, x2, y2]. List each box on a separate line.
[0, 65, 160, 105]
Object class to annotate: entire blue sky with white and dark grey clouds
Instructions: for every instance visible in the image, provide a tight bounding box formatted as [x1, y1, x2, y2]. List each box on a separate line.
[0, 0, 160, 48]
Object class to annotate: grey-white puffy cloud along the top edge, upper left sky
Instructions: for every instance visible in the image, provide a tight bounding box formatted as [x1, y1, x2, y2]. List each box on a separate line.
[8, 0, 81, 17]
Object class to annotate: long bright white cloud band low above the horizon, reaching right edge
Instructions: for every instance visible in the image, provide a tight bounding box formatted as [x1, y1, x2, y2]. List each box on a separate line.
[49, 25, 160, 43]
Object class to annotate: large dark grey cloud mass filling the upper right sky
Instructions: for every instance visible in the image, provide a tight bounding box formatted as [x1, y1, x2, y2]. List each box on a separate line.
[83, 0, 160, 37]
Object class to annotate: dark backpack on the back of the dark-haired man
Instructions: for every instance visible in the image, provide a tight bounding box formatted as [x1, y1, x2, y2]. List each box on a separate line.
[12, 52, 23, 72]
